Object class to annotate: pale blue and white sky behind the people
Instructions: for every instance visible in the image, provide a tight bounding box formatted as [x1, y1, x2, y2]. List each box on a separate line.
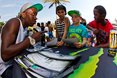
[0, 0, 117, 23]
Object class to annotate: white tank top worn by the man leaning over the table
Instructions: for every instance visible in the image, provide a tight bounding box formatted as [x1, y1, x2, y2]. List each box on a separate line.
[0, 18, 27, 75]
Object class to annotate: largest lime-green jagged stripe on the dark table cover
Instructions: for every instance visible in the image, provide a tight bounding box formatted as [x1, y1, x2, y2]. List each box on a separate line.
[68, 48, 104, 78]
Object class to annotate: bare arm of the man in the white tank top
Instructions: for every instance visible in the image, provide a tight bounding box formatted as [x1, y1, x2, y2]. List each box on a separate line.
[1, 18, 40, 61]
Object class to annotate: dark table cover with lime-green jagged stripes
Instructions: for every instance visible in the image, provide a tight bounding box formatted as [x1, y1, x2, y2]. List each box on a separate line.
[13, 46, 117, 78]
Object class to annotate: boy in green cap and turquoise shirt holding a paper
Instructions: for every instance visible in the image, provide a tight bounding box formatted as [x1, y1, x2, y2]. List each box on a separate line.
[67, 10, 87, 48]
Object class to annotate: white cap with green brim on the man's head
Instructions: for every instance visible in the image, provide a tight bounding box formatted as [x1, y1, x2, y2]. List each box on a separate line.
[19, 3, 43, 14]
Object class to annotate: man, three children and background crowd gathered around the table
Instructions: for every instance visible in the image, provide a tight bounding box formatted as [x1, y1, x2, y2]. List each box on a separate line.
[0, 3, 113, 78]
